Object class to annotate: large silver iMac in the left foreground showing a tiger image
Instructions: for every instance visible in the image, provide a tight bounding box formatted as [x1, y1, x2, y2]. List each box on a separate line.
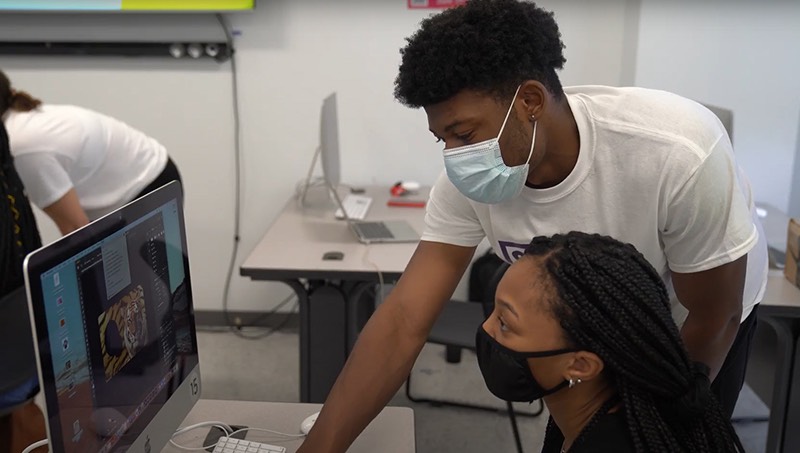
[25, 182, 200, 453]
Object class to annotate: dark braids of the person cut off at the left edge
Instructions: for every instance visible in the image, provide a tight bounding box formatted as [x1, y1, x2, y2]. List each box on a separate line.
[0, 121, 42, 297]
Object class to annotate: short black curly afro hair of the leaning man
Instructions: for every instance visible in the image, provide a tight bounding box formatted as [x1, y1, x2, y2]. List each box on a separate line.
[394, 0, 566, 107]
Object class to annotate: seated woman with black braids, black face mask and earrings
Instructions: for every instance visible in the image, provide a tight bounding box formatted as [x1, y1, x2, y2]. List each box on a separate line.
[476, 232, 744, 453]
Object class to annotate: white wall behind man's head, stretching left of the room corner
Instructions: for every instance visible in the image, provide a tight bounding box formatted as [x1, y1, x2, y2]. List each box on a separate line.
[0, 0, 635, 310]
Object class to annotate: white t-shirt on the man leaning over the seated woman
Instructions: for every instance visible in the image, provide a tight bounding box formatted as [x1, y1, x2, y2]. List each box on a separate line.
[422, 86, 768, 323]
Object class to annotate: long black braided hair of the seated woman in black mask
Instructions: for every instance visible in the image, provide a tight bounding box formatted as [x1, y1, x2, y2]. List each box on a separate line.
[525, 232, 744, 453]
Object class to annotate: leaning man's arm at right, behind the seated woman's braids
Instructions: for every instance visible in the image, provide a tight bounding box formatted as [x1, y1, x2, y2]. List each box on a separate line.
[672, 255, 747, 381]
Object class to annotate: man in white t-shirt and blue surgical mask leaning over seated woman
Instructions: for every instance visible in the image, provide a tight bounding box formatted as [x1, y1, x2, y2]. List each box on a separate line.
[299, 0, 767, 453]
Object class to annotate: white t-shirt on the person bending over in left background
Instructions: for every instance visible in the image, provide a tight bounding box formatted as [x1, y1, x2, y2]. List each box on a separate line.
[3, 105, 167, 220]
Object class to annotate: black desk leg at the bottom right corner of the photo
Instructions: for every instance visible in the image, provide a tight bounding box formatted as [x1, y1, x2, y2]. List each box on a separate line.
[762, 316, 800, 453]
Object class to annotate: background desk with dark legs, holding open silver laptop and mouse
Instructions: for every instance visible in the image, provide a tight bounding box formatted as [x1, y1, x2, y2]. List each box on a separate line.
[240, 187, 428, 403]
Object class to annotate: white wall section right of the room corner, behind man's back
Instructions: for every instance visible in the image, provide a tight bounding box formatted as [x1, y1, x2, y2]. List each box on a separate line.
[636, 0, 800, 210]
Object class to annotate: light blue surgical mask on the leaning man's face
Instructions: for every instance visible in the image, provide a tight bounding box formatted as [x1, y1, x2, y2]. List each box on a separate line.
[444, 87, 536, 204]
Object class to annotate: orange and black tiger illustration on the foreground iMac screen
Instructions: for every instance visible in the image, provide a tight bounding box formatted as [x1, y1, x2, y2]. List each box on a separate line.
[97, 285, 147, 381]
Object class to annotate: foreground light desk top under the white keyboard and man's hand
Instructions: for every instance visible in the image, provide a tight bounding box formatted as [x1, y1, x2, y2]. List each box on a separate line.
[162, 400, 416, 453]
